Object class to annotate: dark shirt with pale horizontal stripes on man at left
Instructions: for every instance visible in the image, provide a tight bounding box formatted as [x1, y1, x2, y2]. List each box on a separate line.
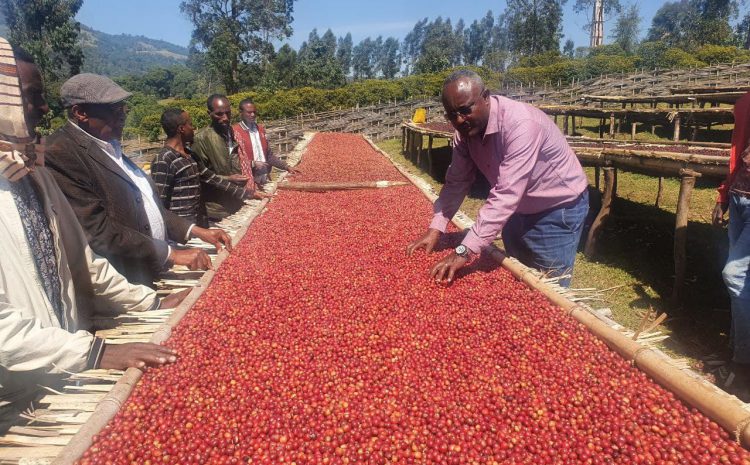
[151, 147, 245, 226]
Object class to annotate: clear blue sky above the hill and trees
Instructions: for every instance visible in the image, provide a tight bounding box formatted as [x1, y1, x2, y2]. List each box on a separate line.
[77, 0, 700, 49]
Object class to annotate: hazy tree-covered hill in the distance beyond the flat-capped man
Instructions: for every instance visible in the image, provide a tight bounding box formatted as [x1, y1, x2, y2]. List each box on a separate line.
[80, 24, 188, 76]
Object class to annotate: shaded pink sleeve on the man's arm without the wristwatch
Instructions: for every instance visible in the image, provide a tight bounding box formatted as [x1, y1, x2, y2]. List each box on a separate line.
[430, 138, 476, 232]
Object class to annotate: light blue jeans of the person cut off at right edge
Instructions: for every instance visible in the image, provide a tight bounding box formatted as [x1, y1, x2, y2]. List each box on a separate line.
[721, 193, 750, 363]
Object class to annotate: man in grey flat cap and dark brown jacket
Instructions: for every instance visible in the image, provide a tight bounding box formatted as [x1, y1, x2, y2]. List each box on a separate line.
[46, 73, 231, 286]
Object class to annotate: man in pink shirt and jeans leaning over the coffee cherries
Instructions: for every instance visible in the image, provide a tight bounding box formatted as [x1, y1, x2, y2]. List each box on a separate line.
[407, 70, 588, 286]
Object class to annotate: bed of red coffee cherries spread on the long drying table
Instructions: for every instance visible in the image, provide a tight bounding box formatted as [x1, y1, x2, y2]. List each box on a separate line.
[79, 134, 750, 465]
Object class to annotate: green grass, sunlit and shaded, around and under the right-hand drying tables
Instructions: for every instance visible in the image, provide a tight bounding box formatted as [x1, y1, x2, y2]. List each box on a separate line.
[378, 127, 729, 366]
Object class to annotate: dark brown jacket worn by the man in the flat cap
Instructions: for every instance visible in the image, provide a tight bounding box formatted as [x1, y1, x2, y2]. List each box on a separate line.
[45, 122, 190, 286]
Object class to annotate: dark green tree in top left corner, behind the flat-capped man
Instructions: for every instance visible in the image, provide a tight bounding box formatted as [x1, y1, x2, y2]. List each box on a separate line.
[0, 0, 83, 110]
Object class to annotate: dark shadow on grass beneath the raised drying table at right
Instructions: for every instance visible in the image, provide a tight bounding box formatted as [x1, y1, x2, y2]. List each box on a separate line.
[593, 194, 729, 355]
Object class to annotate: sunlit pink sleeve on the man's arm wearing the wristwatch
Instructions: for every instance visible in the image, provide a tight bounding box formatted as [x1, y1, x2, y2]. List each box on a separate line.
[463, 120, 543, 253]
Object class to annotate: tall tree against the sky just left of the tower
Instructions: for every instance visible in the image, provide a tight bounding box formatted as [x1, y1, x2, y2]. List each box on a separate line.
[506, 0, 567, 56]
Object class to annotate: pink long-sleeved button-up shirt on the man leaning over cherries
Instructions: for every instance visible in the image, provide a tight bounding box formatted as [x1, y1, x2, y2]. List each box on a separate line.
[430, 95, 588, 253]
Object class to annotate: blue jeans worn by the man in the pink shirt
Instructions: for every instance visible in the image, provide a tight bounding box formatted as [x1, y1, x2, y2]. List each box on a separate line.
[503, 190, 589, 287]
